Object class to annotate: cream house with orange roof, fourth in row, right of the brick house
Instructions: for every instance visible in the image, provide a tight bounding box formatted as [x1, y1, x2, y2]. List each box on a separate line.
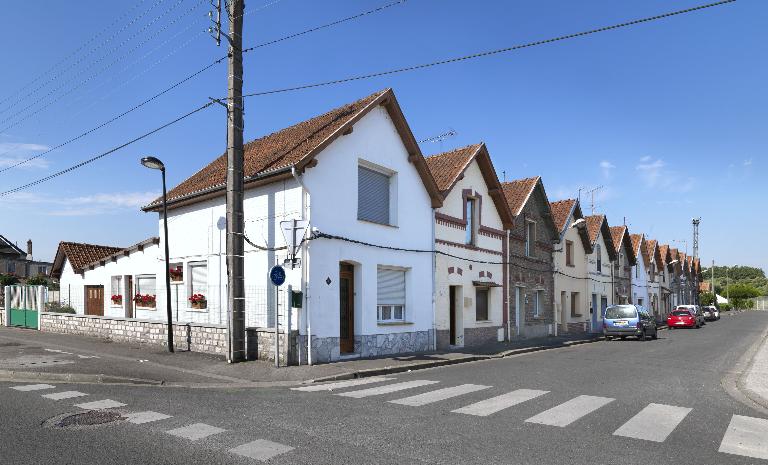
[551, 199, 593, 333]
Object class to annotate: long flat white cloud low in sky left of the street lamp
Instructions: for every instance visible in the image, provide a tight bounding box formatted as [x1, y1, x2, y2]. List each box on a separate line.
[0, 192, 159, 216]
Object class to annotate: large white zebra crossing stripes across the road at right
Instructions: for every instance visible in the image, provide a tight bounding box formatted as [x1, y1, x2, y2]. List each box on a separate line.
[293, 377, 768, 460]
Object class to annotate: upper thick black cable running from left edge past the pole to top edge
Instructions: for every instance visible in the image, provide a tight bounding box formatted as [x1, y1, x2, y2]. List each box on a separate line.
[0, 0, 405, 173]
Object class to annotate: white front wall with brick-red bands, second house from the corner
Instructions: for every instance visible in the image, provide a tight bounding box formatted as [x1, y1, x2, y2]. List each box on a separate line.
[435, 159, 506, 348]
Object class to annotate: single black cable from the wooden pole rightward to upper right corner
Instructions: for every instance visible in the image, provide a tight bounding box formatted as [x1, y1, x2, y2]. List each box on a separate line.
[243, 0, 736, 97]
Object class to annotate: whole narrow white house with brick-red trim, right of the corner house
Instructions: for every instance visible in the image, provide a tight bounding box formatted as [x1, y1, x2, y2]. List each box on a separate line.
[427, 144, 513, 348]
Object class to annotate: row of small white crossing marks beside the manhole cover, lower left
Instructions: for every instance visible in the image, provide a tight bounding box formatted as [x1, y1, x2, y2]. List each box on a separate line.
[10, 378, 296, 462]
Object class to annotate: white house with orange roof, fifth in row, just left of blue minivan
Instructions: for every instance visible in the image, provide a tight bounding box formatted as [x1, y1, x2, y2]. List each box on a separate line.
[585, 215, 618, 333]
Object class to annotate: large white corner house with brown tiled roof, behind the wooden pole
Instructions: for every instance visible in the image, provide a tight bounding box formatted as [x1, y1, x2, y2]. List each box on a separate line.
[144, 89, 442, 363]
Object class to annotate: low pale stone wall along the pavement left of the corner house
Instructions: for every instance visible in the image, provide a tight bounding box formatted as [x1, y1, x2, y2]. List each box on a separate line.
[40, 312, 227, 355]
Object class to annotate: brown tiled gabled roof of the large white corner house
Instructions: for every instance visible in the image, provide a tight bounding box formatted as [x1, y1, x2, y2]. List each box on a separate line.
[143, 89, 442, 211]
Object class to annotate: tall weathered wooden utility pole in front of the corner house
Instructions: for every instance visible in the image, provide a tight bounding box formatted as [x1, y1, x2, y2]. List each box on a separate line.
[224, 0, 246, 362]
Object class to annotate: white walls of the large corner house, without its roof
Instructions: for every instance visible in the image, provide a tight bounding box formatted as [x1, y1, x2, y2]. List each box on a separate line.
[158, 102, 434, 363]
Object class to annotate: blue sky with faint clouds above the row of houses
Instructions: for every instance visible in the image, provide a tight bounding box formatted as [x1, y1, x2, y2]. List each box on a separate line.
[0, 0, 768, 269]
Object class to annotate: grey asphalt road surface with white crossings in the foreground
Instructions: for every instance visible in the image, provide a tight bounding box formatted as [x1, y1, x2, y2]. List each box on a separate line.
[0, 312, 768, 465]
